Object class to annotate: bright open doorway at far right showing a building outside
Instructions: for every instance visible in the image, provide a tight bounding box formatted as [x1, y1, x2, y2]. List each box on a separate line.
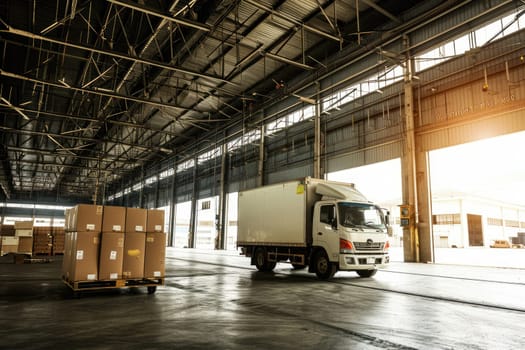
[429, 132, 525, 267]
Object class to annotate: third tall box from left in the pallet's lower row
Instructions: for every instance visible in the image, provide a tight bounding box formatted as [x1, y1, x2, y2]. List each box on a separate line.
[122, 232, 146, 279]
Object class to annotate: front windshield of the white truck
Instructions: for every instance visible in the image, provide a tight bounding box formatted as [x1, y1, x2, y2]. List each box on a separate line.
[337, 202, 386, 230]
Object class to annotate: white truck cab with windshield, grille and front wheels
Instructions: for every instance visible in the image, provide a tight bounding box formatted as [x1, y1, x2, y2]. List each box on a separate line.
[309, 184, 390, 279]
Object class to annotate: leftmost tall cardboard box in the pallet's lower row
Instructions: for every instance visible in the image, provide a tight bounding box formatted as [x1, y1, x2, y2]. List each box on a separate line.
[68, 232, 100, 282]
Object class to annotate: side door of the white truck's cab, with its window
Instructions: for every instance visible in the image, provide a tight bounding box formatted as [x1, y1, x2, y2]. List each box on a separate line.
[313, 203, 339, 262]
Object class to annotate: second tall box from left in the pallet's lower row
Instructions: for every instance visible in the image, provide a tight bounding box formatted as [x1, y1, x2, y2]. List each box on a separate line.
[98, 231, 124, 280]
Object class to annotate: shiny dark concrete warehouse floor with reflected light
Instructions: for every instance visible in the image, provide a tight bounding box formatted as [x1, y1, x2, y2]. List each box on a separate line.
[0, 248, 525, 349]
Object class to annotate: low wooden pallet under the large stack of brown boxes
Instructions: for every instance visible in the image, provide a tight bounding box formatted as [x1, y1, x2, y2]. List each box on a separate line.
[62, 278, 164, 294]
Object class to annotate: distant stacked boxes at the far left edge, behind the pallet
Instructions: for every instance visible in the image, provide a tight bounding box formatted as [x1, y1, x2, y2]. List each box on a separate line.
[0, 221, 33, 255]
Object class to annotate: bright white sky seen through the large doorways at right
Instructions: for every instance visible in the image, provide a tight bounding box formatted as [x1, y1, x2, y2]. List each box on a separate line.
[328, 132, 525, 207]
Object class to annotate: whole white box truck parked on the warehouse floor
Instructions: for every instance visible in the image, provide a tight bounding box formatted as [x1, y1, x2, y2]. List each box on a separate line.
[237, 177, 390, 279]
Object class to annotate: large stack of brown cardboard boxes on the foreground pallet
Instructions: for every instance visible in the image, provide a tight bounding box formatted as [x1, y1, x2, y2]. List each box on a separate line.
[62, 204, 166, 282]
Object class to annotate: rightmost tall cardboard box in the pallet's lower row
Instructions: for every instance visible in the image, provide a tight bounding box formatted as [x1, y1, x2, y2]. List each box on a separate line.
[144, 232, 166, 278]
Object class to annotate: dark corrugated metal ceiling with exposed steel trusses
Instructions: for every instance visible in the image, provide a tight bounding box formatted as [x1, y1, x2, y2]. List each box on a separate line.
[0, 0, 462, 200]
